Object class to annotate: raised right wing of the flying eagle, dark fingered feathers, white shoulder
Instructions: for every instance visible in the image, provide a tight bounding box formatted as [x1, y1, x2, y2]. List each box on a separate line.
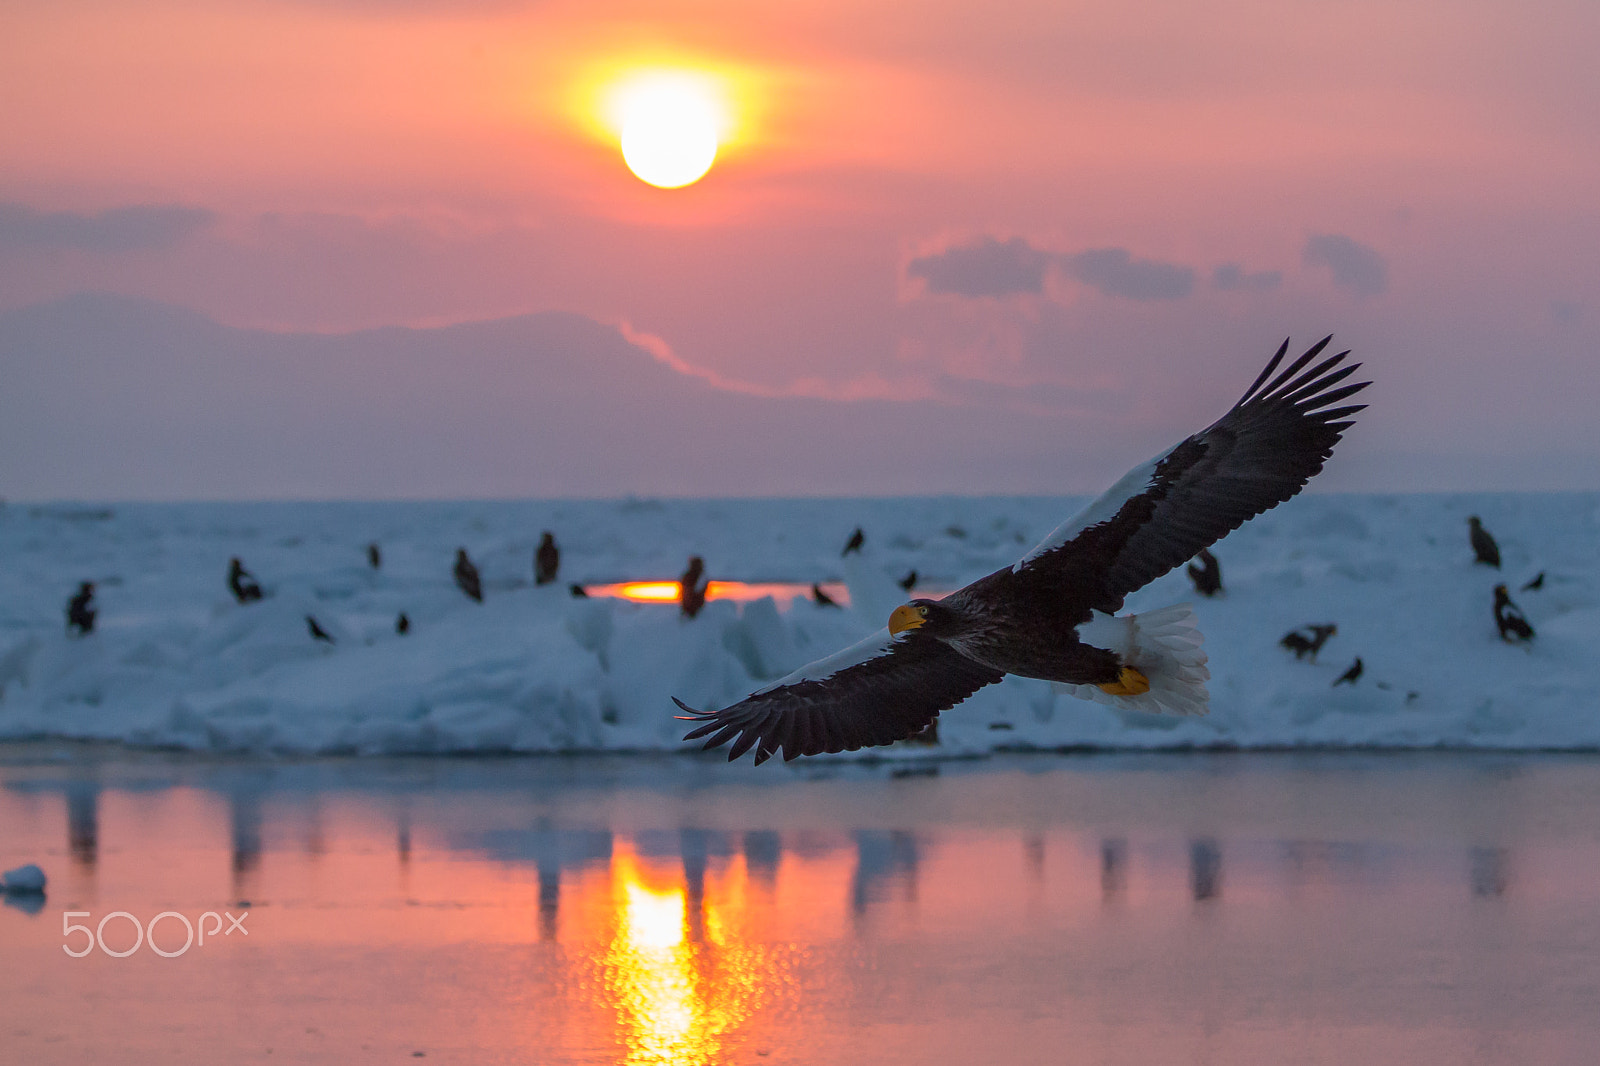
[1011, 336, 1370, 619]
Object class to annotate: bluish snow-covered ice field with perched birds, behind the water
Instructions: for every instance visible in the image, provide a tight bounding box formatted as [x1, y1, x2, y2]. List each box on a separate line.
[0, 493, 1600, 757]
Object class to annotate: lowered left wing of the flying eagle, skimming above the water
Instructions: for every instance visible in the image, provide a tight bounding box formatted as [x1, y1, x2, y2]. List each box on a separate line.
[672, 629, 1003, 765]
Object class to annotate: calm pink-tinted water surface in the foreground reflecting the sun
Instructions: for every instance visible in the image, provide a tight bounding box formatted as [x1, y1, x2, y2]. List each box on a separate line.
[0, 744, 1600, 1064]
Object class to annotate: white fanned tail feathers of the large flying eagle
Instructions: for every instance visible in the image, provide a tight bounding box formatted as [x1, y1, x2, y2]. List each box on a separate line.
[1054, 603, 1211, 714]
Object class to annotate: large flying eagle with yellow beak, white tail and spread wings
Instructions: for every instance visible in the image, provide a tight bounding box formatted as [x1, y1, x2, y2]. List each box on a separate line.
[675, 338, 1366, 762]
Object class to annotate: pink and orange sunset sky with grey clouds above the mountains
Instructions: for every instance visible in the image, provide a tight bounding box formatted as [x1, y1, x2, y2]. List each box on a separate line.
[0, 0, 1600, 495]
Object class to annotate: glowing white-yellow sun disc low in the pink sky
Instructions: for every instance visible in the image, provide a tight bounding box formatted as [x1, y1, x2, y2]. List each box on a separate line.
[610, 70, 728, 189]
